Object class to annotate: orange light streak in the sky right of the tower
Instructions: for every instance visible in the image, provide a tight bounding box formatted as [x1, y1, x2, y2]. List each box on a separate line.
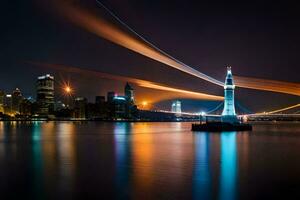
[234, 76, 300, 96]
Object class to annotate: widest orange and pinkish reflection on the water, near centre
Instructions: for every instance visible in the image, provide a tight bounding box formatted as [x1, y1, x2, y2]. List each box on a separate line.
[132, 123, 194, 198]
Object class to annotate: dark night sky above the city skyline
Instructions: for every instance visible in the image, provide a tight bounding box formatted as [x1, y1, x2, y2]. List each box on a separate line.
[0, 0, 300, 111]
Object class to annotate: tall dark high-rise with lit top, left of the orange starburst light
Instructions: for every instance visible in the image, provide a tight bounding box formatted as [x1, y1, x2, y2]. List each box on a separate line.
[36, 74, 54, 115]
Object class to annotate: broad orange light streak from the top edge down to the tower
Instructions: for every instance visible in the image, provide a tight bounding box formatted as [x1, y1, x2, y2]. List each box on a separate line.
[51, 0, 224, 86]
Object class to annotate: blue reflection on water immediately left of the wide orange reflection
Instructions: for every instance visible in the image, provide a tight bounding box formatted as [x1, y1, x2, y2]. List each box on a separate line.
[114, 122, 131, 199]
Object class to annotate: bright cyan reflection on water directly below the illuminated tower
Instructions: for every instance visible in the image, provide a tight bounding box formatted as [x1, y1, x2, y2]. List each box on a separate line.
[219, 132, 237, 200]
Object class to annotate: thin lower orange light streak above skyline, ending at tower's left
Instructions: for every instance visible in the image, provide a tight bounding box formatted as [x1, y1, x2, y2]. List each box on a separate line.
[28, 62, 224, 101]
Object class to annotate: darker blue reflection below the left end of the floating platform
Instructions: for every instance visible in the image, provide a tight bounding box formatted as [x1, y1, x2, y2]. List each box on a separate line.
[193, 133, 211, 199]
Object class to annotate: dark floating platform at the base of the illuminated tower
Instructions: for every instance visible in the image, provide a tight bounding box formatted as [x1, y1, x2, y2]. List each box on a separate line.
[192, 122, 252, 132]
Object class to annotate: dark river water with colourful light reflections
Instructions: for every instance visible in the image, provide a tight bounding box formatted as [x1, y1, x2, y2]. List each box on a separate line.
[0, 122, 300, 199]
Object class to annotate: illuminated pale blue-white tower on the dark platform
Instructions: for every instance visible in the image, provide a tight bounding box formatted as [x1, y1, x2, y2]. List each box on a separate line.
[222, 67, 238, 123]
